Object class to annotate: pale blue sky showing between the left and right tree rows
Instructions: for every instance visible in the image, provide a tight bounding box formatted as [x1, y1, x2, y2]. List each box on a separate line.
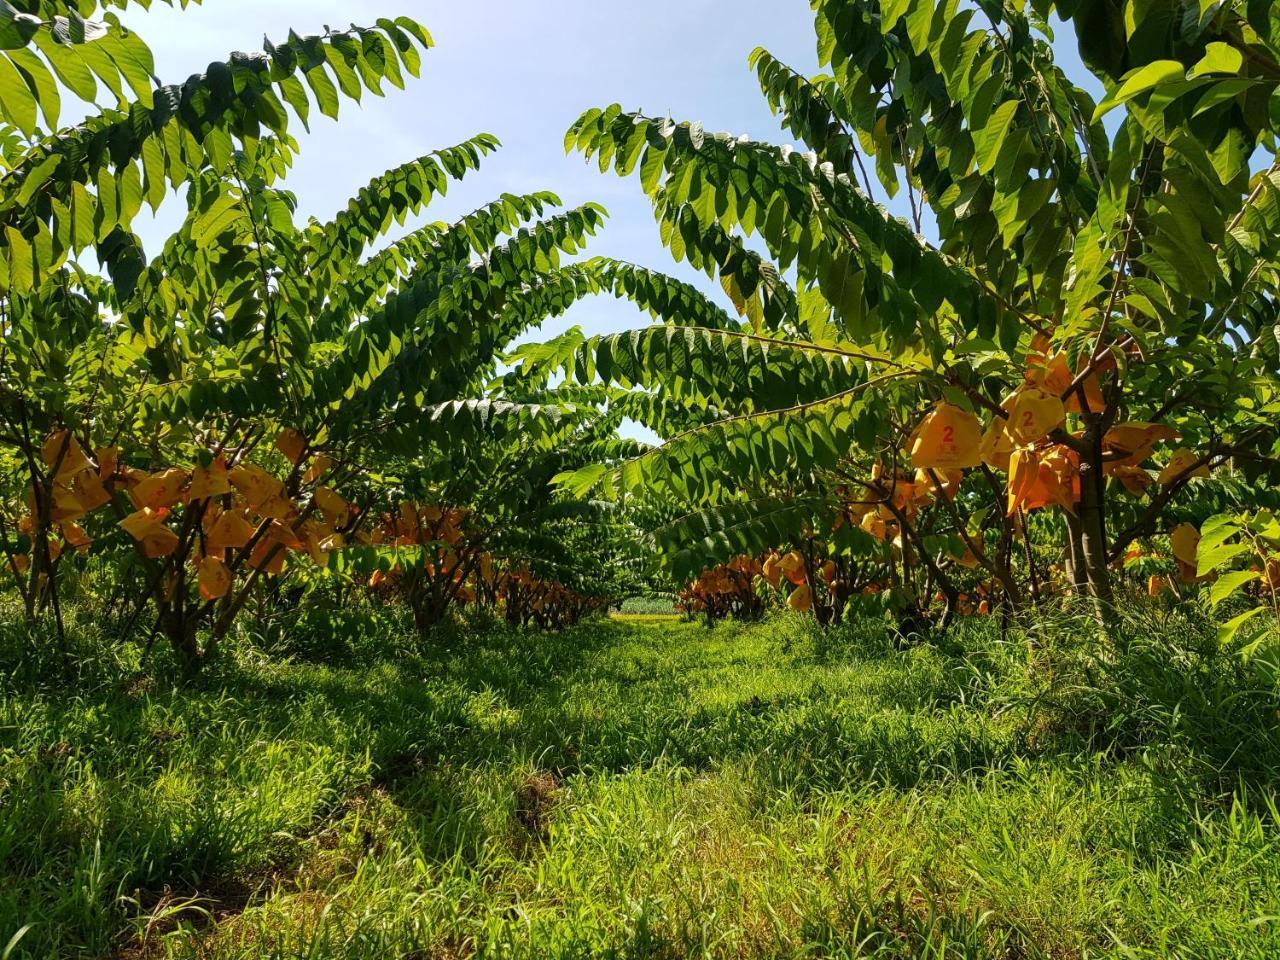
[115, 0, 844, 335]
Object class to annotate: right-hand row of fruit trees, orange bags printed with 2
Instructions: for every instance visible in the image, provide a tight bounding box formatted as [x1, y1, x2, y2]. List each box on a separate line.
[521, 0, 1280, 642]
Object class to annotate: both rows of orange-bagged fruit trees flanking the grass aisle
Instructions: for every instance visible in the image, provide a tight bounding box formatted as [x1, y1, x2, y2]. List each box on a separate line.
[10, 0, 1280, 664]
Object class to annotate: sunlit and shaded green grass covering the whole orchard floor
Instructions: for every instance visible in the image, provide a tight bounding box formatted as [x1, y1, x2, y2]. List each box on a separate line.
[0, 611, 1280, 960]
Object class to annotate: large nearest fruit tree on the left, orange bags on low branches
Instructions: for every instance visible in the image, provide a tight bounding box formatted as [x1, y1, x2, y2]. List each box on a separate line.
[0, 5, 634, 667]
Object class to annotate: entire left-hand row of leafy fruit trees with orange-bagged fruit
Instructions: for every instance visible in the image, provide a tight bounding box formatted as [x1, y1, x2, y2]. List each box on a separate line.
[0, 0, 650, 667]
